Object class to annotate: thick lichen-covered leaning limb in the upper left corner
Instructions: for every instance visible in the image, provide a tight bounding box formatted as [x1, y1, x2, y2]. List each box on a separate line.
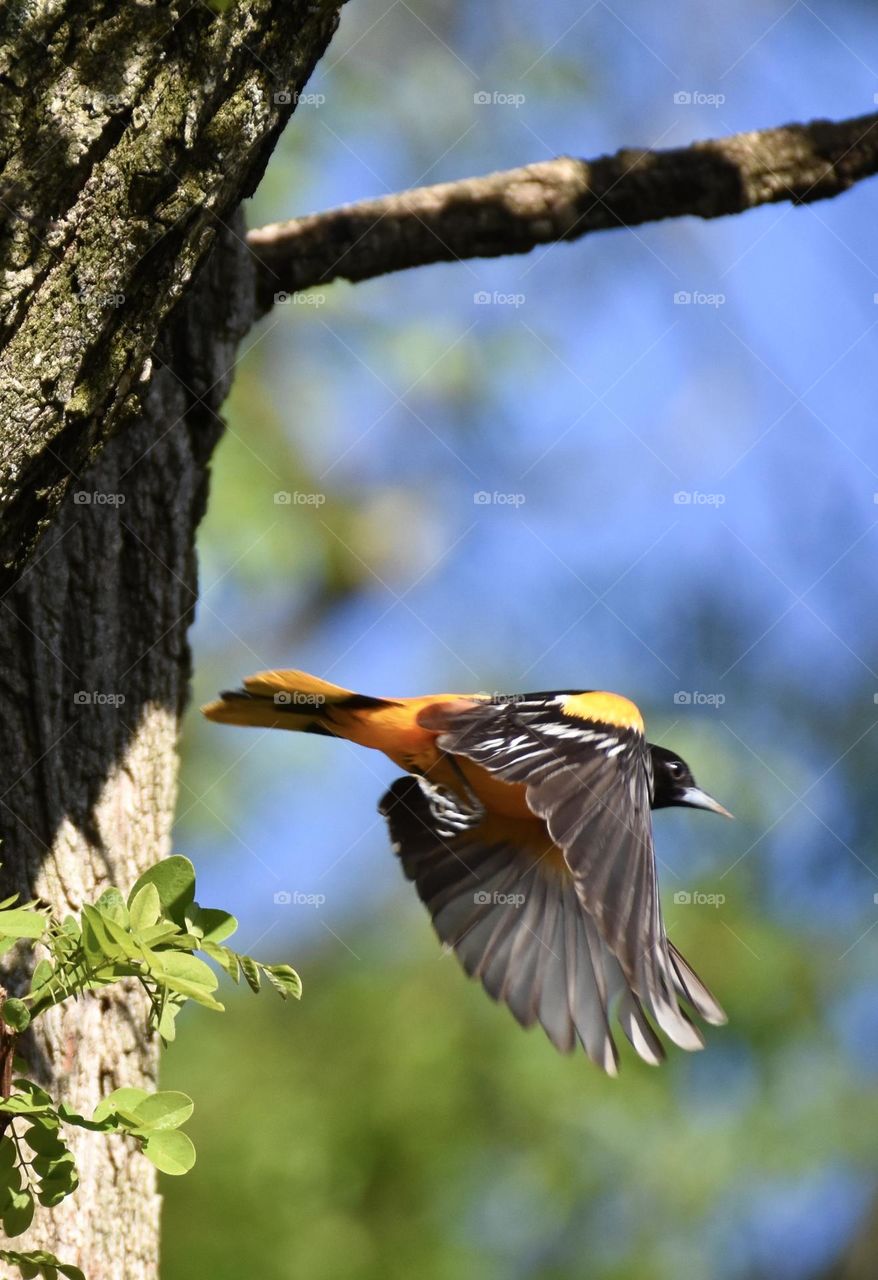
[0, 0, 338, 584]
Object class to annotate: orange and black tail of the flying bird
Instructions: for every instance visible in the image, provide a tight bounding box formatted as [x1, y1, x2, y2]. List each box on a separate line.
[201, 671, 384, 733]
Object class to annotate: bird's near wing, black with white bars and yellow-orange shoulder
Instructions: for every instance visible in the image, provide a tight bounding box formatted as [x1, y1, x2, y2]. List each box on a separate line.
[419, 694, 724, 1050]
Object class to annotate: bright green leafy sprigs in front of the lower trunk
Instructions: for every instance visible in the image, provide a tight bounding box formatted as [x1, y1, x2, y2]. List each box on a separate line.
[0, 856, 302, 1280]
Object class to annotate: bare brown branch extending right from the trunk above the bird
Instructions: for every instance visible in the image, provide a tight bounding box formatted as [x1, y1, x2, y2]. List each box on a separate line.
[248, 114, 878, 307]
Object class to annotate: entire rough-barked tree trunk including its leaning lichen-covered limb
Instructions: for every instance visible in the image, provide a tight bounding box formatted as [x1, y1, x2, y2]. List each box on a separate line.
[0, 0, 338, 1280]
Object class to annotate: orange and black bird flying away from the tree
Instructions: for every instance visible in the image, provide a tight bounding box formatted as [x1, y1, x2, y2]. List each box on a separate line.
[202, 671, 731, 1075]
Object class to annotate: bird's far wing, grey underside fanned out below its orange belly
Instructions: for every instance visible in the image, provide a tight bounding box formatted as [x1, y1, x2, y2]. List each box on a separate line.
[380, 777, 664, 1075]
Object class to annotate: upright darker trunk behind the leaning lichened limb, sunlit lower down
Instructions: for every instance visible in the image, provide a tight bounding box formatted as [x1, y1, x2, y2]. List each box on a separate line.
[0, 215, 253, 1280]
